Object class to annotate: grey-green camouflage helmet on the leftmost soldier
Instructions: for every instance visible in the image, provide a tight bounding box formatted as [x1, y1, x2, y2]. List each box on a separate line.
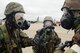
[4, 2, 25, 15]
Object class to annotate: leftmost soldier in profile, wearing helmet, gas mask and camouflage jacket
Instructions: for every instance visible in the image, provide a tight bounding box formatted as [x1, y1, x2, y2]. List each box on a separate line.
[0, 2, 33, 53]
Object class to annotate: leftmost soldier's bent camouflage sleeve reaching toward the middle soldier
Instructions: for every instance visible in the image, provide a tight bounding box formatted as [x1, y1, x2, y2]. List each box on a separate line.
[20, 31, 34, 47]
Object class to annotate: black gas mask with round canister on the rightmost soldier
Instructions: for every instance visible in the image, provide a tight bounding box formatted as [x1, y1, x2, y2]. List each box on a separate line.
[60, 8, 75, 30]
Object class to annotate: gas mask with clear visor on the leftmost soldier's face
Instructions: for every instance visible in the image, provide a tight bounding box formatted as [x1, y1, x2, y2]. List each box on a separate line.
[15, 13, 30, 30]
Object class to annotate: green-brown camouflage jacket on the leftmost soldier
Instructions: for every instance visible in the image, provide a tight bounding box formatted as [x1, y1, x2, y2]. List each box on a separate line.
[0, 24, 33, 53]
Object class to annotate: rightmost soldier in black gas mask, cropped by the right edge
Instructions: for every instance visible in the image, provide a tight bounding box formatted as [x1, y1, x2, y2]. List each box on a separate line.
[55, 0, 80, 53]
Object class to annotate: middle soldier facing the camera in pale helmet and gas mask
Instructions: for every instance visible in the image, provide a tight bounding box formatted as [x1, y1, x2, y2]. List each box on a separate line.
[33, 16, 61, 53]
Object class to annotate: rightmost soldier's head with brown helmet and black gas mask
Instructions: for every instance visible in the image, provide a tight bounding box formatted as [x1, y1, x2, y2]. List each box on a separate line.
[61, 0, 80, 30]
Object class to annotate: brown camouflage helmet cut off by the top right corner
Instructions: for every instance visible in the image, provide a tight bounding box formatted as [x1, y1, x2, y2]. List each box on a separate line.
[61, 0, 80, 10]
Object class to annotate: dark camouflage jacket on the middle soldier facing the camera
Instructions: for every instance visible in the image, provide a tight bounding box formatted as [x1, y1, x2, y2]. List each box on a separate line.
[33, 29, 61, 53]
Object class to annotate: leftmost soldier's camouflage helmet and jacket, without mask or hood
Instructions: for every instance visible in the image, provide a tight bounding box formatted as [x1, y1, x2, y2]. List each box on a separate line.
[0, 2, 33, 53]
